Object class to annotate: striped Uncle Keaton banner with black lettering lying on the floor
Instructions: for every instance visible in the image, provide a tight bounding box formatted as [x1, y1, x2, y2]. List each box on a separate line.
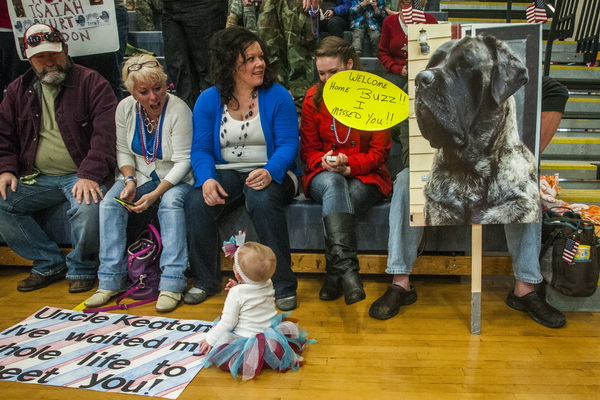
[0, 307, 212, 399]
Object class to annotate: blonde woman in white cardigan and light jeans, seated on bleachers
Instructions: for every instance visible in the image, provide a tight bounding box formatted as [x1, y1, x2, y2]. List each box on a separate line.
[85, 55, 194, 312]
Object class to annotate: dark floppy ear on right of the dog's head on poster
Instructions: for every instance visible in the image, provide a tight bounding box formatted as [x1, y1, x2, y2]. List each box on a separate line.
[482, 36, 529, 104]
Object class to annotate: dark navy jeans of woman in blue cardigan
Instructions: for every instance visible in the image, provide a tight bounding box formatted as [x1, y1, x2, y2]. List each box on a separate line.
[185, 170, 298, 299]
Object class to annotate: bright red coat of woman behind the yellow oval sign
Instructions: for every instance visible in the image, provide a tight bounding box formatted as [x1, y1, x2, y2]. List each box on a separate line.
[300, 86, 392, 197]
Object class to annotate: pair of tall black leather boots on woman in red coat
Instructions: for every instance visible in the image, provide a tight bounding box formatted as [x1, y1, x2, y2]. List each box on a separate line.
[319, 213, 366, 305]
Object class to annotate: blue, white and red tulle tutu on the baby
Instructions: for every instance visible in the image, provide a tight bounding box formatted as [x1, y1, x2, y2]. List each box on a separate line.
[202, 313, 316, 381]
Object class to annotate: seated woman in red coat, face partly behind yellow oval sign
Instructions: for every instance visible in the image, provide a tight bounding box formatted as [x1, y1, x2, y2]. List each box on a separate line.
[300, 36, 392, 305]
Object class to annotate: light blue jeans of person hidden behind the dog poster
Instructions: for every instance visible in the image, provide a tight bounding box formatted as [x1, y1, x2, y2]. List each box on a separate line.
[385, 168, 542, 284]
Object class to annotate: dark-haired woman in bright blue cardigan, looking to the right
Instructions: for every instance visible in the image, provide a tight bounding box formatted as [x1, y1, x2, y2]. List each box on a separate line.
[184, 26, 299, 311]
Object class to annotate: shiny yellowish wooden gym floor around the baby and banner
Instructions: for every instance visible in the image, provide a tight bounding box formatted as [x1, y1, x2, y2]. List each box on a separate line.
[0, 266, 600, 400]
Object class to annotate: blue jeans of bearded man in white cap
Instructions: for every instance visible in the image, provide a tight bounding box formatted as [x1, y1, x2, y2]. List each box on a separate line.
[0, 174, 106, 279]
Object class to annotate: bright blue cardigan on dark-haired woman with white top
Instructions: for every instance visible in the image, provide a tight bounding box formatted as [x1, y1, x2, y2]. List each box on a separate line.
[191, 84, 300, 187]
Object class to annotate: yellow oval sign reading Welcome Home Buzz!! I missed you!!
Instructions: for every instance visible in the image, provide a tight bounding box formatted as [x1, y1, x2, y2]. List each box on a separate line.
[323, 71, 408, 131]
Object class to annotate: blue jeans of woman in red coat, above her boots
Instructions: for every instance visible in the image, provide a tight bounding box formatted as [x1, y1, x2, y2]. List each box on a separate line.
[310, 171, 382, 217]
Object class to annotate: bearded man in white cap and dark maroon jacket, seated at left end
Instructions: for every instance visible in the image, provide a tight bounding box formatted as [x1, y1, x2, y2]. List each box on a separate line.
[0, 24, 117, 293]
